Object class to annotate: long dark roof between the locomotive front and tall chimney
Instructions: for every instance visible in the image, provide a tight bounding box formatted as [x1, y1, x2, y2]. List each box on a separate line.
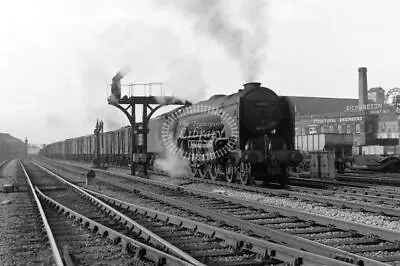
[289, 96, 358, 115]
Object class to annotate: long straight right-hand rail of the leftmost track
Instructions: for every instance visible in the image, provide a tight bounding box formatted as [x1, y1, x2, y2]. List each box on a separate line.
[32, 162, 204, 265]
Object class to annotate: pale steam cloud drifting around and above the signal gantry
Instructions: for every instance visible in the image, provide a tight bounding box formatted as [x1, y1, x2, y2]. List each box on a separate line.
[78, 19, 207, 130]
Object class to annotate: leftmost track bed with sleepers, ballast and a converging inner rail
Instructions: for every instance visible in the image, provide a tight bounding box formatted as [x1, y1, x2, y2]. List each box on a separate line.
[21, 159, 197, 265]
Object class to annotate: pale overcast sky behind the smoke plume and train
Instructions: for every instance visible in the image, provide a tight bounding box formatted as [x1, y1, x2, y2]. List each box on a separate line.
[0, 0, 400, 144]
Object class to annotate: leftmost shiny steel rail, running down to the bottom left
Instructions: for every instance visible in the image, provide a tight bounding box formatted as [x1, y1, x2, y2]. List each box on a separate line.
[19, 161, 64, 266]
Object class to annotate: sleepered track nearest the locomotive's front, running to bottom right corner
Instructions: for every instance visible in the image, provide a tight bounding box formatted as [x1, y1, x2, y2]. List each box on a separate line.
[36, 158, 400, 265]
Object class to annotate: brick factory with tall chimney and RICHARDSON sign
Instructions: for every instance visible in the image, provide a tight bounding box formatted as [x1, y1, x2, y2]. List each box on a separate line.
[291, 67, 400, 155]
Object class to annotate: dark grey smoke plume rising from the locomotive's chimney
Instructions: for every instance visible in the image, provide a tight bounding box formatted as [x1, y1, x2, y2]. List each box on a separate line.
[156, 0, 268, 81]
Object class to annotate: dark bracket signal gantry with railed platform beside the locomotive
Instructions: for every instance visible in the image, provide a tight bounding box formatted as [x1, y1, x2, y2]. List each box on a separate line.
[108, 71, 191, 176]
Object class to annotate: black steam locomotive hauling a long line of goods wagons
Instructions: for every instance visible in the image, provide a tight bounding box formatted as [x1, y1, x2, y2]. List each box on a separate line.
[41, 82, 303, 187]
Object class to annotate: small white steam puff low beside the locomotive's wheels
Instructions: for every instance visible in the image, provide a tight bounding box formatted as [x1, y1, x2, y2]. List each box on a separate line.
[154, 152, 191, 177]
